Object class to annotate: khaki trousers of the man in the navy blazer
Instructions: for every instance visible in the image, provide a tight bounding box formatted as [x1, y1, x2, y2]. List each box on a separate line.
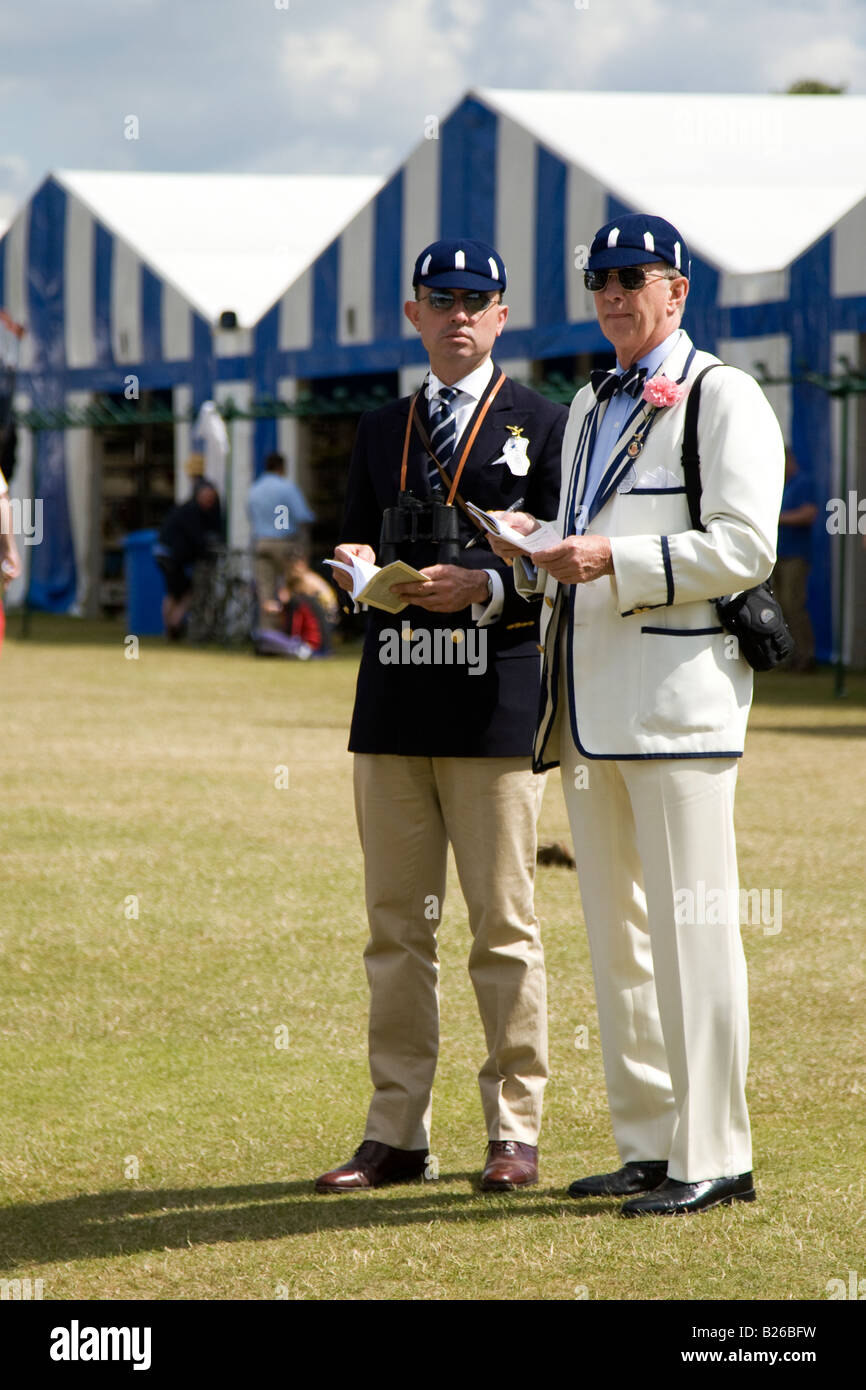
[354, 753, 548, 1150]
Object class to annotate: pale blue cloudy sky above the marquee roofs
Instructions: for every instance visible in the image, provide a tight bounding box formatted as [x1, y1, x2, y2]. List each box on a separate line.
[0, 0, 866, 218]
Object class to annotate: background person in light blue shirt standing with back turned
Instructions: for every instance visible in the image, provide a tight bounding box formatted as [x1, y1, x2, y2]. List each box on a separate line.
[246, 453, 316, 627]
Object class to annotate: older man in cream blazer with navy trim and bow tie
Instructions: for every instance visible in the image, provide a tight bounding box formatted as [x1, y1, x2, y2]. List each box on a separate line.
[496, 214, 784, 1216]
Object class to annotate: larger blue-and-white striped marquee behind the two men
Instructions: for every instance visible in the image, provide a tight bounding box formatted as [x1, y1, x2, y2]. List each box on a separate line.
[254, 89, 866, 660]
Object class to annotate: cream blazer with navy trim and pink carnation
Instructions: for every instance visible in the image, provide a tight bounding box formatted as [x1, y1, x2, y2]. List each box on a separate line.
[514, 331, 784, 770]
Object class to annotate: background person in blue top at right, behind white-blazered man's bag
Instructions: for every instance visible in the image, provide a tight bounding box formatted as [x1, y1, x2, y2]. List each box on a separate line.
[773, 448, 817, 673]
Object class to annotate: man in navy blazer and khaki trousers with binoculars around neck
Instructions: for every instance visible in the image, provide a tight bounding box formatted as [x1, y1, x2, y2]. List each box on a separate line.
[316, 238, 567, 1193]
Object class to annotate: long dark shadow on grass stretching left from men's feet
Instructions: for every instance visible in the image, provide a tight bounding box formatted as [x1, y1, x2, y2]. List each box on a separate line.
[0, 1173, 617, 1270]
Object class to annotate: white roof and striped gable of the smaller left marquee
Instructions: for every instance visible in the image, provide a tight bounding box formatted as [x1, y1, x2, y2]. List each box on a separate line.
[0, 171, 381, 367]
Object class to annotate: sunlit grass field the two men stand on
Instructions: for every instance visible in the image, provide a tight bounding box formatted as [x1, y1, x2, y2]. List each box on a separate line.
[0, 617, 866, 1300]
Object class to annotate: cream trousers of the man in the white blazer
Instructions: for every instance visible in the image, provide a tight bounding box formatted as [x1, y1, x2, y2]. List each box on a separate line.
[560, 706, 752, 1183]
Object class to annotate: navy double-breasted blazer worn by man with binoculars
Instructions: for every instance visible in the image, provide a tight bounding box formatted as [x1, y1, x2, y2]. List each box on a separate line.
[342, 368, 569, 758]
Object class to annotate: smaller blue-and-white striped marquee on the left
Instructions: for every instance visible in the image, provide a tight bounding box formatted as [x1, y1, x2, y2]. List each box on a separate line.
[0, 172, 379, 612]
